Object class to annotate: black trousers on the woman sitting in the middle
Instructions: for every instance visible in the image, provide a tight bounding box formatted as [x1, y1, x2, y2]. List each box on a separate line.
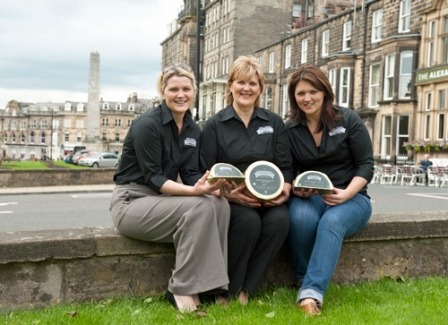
[228, 203, 289, 296]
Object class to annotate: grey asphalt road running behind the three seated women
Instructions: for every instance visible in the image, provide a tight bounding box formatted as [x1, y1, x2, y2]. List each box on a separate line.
[0, 184, 448, 232]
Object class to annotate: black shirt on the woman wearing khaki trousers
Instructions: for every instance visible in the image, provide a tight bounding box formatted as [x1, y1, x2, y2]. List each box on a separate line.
[114, 102, 201, 192]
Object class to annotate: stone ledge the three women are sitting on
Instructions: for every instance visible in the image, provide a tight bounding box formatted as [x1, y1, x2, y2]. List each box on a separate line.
[0, 211, 448, 310]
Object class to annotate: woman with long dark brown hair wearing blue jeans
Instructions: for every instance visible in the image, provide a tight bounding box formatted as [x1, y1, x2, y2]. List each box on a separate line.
[287, 65, 373, 316]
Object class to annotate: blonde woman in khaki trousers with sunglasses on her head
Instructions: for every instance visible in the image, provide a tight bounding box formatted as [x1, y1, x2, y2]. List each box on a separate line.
[110, 64, 230, 312]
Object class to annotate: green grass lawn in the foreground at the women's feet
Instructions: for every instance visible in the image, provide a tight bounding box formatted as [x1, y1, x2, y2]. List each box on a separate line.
[0, 277, 448, 325]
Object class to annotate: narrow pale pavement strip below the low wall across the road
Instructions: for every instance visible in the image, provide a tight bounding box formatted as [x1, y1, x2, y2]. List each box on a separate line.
[0, 184, 115, 195]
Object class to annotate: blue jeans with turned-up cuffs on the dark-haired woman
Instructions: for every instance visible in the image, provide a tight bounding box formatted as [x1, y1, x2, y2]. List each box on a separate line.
[289, 194, 372, 306]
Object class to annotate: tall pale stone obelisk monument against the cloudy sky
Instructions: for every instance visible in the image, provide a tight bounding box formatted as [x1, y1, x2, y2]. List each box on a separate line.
[86, 51, 102, 151]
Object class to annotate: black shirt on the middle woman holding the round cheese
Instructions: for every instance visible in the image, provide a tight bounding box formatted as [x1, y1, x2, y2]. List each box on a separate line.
[200, 106, 293, 183]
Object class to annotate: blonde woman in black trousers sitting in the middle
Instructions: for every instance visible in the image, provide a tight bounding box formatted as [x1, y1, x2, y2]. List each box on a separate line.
[201, 56, 293, 304]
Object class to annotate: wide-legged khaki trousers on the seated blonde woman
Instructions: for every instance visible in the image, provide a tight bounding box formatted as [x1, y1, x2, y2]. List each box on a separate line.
[109, 183, 230, 295]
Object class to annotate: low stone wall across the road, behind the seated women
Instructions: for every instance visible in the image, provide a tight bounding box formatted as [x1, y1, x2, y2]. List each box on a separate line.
[0, 168, 115, 187]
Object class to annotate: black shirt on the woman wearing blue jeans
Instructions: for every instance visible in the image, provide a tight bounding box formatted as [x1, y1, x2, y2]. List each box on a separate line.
[286, 107, 374, 194]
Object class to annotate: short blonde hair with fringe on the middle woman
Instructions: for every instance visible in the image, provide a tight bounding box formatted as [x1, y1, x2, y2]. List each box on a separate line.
[226, 55, 264, 107]
